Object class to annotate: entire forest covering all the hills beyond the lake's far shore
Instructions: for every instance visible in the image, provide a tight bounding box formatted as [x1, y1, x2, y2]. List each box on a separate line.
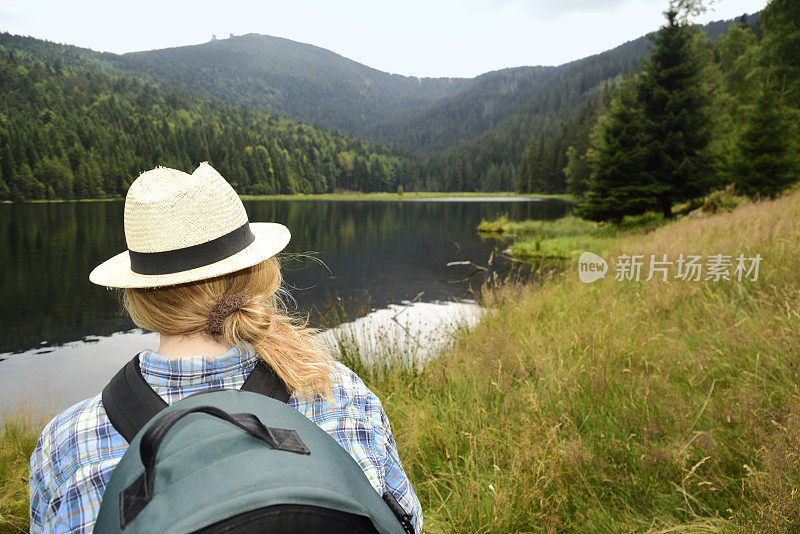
[0, 5, 780, 199]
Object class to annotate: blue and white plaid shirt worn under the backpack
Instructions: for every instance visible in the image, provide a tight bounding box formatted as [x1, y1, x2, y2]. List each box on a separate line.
[30, 347, 422, 533]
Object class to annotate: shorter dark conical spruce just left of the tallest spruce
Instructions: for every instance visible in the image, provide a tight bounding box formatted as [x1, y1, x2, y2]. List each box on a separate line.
[578, 78, 665, 222]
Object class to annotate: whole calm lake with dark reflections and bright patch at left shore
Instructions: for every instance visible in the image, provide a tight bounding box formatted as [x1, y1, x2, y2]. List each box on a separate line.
[0, 197, 569, 410]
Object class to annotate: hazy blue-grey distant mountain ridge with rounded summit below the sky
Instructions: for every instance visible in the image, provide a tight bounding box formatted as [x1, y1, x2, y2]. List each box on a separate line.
[110, 16, 748, 159]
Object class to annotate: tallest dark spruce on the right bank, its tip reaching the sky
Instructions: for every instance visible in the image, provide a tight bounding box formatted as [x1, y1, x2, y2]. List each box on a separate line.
[637, 3, 712, 217]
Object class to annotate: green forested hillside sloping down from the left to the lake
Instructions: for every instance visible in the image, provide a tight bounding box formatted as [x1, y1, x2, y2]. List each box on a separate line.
[0, 34, 404, 200]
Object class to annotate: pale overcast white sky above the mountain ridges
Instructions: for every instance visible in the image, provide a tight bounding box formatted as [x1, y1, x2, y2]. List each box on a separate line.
[0, 0, 767, 77]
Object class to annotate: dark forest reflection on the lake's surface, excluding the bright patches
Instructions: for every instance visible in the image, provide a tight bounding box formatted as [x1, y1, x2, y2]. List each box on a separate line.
[0, 199, 568, 356]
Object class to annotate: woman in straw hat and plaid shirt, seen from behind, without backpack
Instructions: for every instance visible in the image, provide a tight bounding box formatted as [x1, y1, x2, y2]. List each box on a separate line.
[30, 163, 422, 533]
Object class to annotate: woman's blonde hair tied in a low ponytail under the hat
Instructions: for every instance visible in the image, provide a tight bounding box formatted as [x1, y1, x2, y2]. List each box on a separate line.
[124, 257, 333, 398]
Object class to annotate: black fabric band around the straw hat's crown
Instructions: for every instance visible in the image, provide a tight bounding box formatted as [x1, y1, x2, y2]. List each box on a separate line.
[128, 223, 256, 275]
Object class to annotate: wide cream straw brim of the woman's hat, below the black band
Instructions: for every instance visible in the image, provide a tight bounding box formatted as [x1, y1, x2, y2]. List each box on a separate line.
[89, 223, 291, 288]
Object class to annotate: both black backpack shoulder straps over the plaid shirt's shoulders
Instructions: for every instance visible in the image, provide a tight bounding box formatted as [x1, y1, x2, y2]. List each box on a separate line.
[102, 354, 289, 443]
